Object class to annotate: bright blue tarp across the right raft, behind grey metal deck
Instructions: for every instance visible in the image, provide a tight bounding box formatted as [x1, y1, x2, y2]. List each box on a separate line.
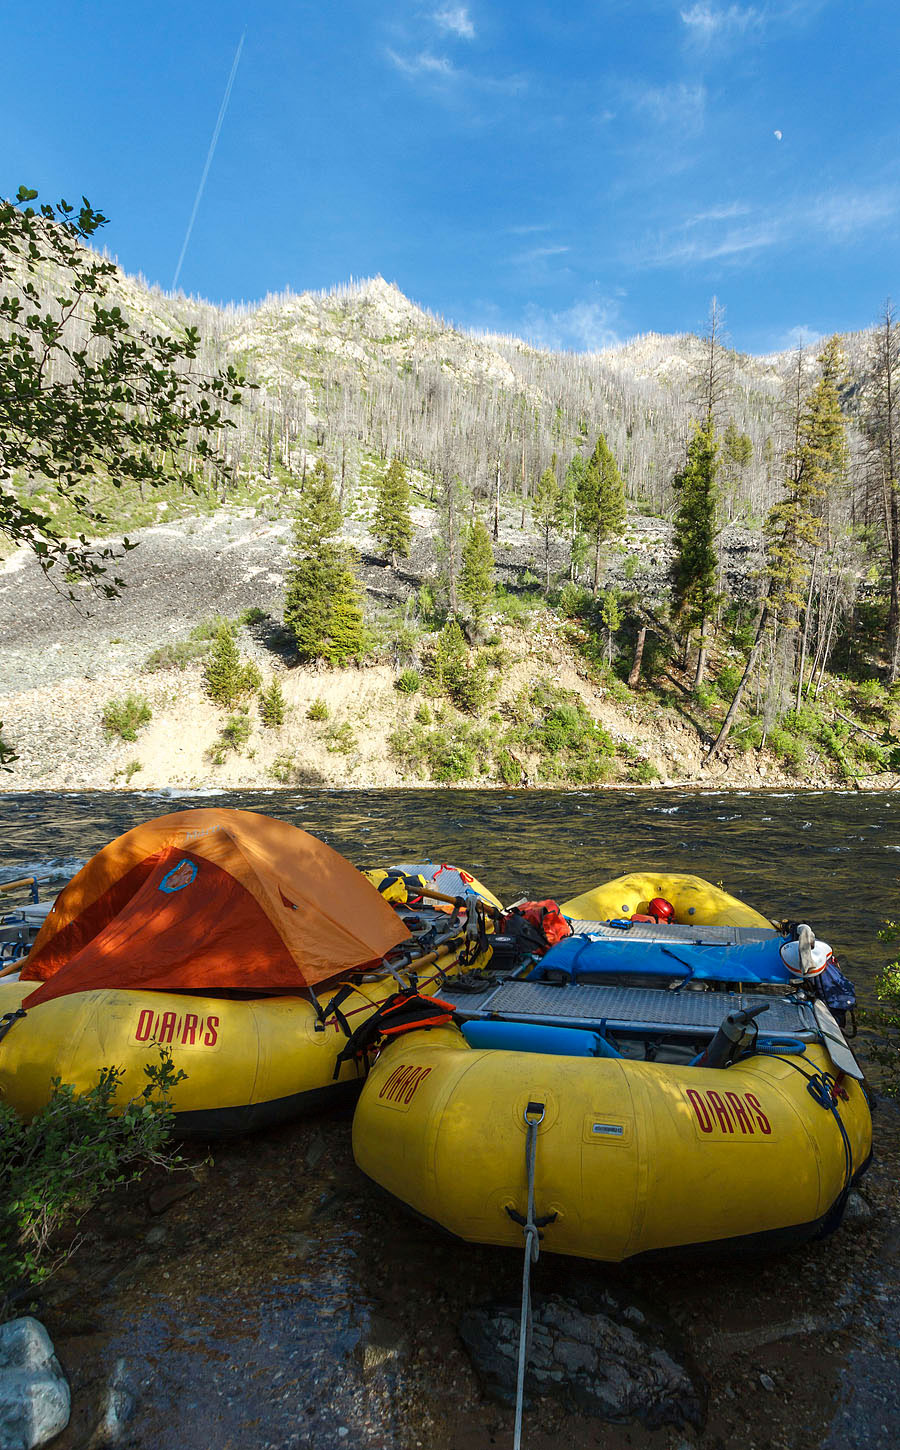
[530, 937, 797, 983]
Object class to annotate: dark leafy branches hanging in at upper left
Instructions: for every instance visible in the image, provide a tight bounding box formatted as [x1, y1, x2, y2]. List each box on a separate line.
[0, 187, 243, 596]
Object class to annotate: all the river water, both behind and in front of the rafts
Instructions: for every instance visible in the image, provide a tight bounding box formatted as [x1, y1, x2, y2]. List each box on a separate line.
[0, 790, 900, 1450]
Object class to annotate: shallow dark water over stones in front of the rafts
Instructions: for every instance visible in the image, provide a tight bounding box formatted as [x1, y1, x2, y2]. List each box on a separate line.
[8, 1106, 900, 1450]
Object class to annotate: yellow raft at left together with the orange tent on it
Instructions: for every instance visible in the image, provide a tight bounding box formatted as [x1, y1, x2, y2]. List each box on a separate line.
[0, 809, 499, 1134]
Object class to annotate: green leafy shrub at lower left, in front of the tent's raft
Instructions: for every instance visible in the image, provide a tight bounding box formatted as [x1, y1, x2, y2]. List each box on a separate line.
[0, 1048, 186, 1295]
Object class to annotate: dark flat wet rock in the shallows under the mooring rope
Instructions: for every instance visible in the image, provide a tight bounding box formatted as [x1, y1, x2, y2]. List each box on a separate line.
[459, 1295, 703, 1427]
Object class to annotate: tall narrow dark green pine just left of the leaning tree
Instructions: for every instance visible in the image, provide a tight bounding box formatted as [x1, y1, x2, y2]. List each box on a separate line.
[672, 415, 719, 689]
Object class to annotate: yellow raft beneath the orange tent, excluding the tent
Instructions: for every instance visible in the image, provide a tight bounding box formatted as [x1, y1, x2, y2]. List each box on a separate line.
[0, 867, 500, 1135]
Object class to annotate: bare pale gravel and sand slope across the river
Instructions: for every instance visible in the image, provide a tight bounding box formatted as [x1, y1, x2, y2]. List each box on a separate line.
[0, 509, 897, 790]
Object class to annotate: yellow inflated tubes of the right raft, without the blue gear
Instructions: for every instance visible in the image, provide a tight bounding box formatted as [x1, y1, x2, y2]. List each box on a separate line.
[354, 873, 871, 1260]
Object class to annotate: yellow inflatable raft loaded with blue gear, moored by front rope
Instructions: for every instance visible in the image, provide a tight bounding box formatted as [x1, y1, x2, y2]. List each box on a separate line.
[354, 873, 871, 1260]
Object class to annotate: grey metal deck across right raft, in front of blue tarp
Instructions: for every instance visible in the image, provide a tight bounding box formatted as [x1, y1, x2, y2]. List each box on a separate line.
[441, 982, 819, 1040]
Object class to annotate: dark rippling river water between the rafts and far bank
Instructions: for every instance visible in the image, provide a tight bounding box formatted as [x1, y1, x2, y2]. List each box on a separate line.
[0, 790, 900, 993]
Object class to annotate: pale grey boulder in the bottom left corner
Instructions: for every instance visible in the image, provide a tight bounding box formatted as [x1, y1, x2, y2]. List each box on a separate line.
[0, 1315, 71, 1450]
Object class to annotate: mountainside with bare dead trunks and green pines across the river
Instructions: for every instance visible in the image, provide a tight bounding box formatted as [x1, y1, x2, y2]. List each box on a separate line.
[7, 221, 900, 783]
